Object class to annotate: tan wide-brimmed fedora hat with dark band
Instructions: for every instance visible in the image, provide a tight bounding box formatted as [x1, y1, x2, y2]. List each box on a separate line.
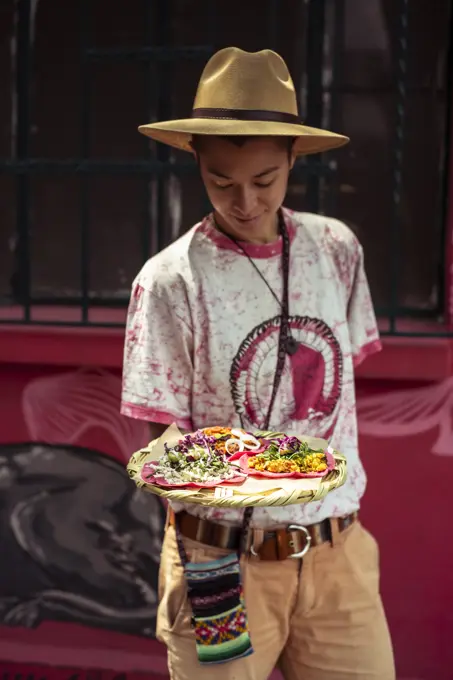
[138, 47, 349, 155]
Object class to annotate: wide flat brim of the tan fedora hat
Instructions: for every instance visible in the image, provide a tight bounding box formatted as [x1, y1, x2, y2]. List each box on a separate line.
[138, 118, 349, 156]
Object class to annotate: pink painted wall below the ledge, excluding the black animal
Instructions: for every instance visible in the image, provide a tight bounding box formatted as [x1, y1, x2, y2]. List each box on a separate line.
[0, 366, 453, 680]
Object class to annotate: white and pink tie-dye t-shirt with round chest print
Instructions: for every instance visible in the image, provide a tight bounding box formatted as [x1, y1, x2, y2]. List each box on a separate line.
[122, 210, 380, 528]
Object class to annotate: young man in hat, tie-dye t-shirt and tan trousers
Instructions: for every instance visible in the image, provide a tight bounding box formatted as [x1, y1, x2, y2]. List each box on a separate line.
[122, 48, 394, 680]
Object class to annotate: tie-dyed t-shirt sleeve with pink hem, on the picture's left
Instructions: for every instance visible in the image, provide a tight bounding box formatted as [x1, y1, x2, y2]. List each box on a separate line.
[121, 283, 193, 430]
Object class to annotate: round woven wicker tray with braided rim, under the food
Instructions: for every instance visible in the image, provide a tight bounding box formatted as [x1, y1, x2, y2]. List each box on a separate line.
[127, 425, 347, 508]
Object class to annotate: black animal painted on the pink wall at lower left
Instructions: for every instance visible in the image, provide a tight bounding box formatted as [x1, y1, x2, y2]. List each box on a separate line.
[0, 442, 164, 637]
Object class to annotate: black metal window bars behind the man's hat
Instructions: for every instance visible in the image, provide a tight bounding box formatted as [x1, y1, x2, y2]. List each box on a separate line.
[0, 0, 453, 336]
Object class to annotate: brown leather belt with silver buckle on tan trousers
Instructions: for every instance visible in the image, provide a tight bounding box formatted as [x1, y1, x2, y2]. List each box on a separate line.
[167, 508, 358, 561]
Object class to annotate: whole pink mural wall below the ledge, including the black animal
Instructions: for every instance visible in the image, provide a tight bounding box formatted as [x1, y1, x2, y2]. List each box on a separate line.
[0, 368, 453, 680]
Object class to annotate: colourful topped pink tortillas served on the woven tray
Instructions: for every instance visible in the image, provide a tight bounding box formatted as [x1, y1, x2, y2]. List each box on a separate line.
[141, 426, 335, 488]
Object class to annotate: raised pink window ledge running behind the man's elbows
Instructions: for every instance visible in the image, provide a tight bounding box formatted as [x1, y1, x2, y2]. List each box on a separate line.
[0, 318, 453, 382]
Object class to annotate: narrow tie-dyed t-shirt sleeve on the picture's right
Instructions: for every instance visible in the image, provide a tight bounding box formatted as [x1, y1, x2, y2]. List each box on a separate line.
[348, 241, 382, 366]
